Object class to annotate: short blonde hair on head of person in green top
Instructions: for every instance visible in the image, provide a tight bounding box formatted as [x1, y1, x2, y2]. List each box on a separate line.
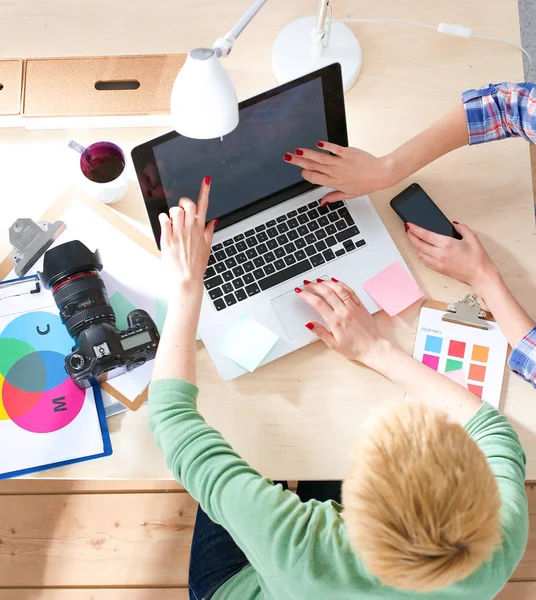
[343, 403, 501, 592]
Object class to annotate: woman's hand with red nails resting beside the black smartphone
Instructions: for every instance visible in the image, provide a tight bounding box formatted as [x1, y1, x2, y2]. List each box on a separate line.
[406, 222, 499, 292]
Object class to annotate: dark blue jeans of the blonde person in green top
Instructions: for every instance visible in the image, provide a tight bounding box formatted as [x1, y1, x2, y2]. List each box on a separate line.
[188, 481, 341, 600]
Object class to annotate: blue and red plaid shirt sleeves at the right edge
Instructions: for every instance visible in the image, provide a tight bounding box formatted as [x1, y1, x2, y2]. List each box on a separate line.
[462, 82, 536, 387]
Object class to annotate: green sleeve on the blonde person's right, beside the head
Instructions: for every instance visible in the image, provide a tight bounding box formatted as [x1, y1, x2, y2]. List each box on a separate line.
[465, 404, 529, 580]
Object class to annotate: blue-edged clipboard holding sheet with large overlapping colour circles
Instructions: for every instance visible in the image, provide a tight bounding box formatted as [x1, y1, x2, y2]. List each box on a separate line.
[0, 275, 113, 480]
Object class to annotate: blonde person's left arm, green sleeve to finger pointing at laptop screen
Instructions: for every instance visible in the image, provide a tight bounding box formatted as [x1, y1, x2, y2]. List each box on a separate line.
[148, 179, 322, 576]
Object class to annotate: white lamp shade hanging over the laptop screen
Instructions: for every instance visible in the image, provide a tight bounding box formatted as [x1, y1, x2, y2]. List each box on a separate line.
[171, 48, 238, 140]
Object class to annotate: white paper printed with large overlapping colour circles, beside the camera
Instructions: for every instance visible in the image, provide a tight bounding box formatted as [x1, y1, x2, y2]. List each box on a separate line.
[0, 291, 104, 474]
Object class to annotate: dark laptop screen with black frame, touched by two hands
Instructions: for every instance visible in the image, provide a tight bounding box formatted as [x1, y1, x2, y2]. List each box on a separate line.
[132, 65, 347, 242]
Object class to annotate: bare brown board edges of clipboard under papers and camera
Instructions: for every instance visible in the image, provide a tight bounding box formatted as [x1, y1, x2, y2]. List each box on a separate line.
[0, 185, 160, 414]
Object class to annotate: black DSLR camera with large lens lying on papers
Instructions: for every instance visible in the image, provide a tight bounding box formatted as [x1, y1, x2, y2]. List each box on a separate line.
[39, 240, 160, 388]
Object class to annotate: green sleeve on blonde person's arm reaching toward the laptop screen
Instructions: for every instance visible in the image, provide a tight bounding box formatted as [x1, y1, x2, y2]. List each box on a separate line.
[149, 379, 315, 577]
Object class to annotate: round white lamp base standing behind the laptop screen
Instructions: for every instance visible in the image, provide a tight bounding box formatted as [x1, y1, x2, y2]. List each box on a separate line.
[272, 17, 363, 92]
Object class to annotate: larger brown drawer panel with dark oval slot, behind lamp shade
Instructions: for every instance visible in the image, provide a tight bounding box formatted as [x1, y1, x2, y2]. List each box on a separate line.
[23, 54, 186, 117]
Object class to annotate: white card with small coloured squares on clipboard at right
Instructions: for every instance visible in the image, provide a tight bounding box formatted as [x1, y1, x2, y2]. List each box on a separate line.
[413, 308, 508, 408]
